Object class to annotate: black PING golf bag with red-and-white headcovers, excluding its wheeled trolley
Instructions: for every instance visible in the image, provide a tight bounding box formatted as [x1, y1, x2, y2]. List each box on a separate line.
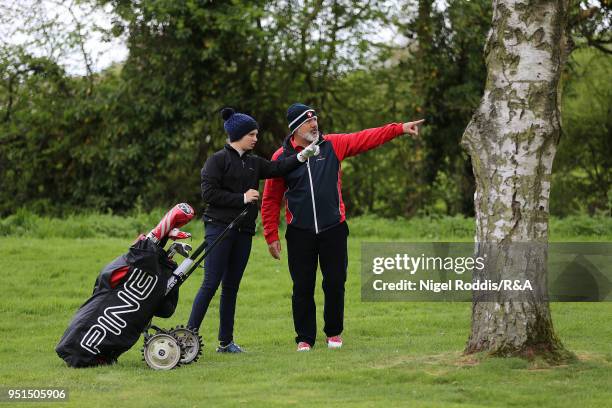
[55, 204, 194, 367]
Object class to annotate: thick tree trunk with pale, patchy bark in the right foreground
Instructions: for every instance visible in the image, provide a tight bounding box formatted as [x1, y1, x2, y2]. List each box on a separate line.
[461, 0, 569, 360]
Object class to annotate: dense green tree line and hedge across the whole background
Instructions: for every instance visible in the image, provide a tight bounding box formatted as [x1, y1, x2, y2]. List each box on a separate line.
[0, 0, 612, 217]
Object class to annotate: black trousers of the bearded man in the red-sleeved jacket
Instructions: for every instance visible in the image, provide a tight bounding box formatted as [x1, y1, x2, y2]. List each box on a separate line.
[285, 222, 349, 346]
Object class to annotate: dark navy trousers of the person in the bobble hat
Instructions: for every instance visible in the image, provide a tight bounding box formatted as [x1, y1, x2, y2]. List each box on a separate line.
[187, 223, 253, 345]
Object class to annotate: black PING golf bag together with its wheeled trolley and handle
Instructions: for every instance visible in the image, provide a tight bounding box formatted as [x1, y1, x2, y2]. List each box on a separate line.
[55, 204, 248, 370]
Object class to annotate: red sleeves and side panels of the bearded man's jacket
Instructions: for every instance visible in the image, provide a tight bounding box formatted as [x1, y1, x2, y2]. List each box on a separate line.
[261, 123, 403, 244]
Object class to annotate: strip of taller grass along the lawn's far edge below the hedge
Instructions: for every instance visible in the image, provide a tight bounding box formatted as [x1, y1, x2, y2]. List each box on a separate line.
[0, 209, 612, 241]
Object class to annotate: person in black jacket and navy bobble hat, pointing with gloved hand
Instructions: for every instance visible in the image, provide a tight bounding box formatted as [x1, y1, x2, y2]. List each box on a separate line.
[187, 108, 319, 353]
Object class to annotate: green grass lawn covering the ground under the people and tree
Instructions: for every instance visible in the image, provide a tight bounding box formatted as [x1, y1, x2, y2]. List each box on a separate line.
[0, 214, 612, 408]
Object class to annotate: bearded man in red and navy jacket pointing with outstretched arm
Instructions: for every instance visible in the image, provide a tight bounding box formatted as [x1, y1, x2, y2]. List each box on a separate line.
[261, 103, 423, 351]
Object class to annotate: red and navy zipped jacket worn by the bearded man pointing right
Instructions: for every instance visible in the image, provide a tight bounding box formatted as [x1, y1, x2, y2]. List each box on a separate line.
[261, 123, 403, 243]
